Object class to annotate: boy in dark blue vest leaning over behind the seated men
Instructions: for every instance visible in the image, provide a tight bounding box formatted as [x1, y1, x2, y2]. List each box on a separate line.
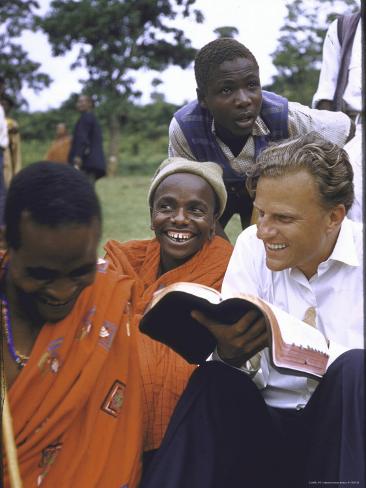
[169, 38, 354, 232]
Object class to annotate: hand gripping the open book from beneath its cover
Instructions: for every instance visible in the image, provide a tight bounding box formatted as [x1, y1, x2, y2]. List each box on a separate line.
[191, 310, 270, 367]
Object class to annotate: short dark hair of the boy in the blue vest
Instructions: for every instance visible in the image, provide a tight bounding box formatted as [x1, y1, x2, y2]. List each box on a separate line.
[194, 37, 259, 93]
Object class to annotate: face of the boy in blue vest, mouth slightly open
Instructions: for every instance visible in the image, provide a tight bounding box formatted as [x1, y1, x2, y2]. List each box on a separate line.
[198, 58, 262, 137]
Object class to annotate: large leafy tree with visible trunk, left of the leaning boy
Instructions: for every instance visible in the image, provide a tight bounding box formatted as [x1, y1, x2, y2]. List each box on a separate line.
[39, 0, 203, 172]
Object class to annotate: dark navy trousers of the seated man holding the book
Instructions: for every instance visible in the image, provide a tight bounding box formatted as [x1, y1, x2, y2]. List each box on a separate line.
[140, 350, 366, 488]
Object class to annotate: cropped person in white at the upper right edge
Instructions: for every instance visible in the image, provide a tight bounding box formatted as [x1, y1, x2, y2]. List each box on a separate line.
[313, 12, 362, 222]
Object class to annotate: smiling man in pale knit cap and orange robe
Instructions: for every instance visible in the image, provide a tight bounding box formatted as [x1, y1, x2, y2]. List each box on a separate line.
[105, 158, 232, 465]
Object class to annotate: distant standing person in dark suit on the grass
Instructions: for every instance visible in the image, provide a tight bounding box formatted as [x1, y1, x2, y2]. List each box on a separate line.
[68, 95, 106, 182]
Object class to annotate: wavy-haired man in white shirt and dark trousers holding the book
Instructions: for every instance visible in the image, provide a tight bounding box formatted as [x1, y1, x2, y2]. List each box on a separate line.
[143, 133, 366, 488]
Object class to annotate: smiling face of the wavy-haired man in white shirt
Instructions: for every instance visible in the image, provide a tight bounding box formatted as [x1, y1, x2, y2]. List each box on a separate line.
[254, 170, 345, 279]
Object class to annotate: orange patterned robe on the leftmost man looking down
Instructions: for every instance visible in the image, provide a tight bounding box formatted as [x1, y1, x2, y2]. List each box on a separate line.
[5, 263, 143, 488]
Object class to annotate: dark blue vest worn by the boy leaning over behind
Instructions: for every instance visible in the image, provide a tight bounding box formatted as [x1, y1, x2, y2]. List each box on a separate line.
[174, 90, 288, 184]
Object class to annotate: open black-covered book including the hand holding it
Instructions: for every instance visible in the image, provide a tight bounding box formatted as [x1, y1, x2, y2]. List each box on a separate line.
[140, 282, 329, 378]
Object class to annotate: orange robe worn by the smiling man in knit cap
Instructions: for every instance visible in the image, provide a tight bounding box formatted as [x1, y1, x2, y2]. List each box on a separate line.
[105, 236, 233, 451]
